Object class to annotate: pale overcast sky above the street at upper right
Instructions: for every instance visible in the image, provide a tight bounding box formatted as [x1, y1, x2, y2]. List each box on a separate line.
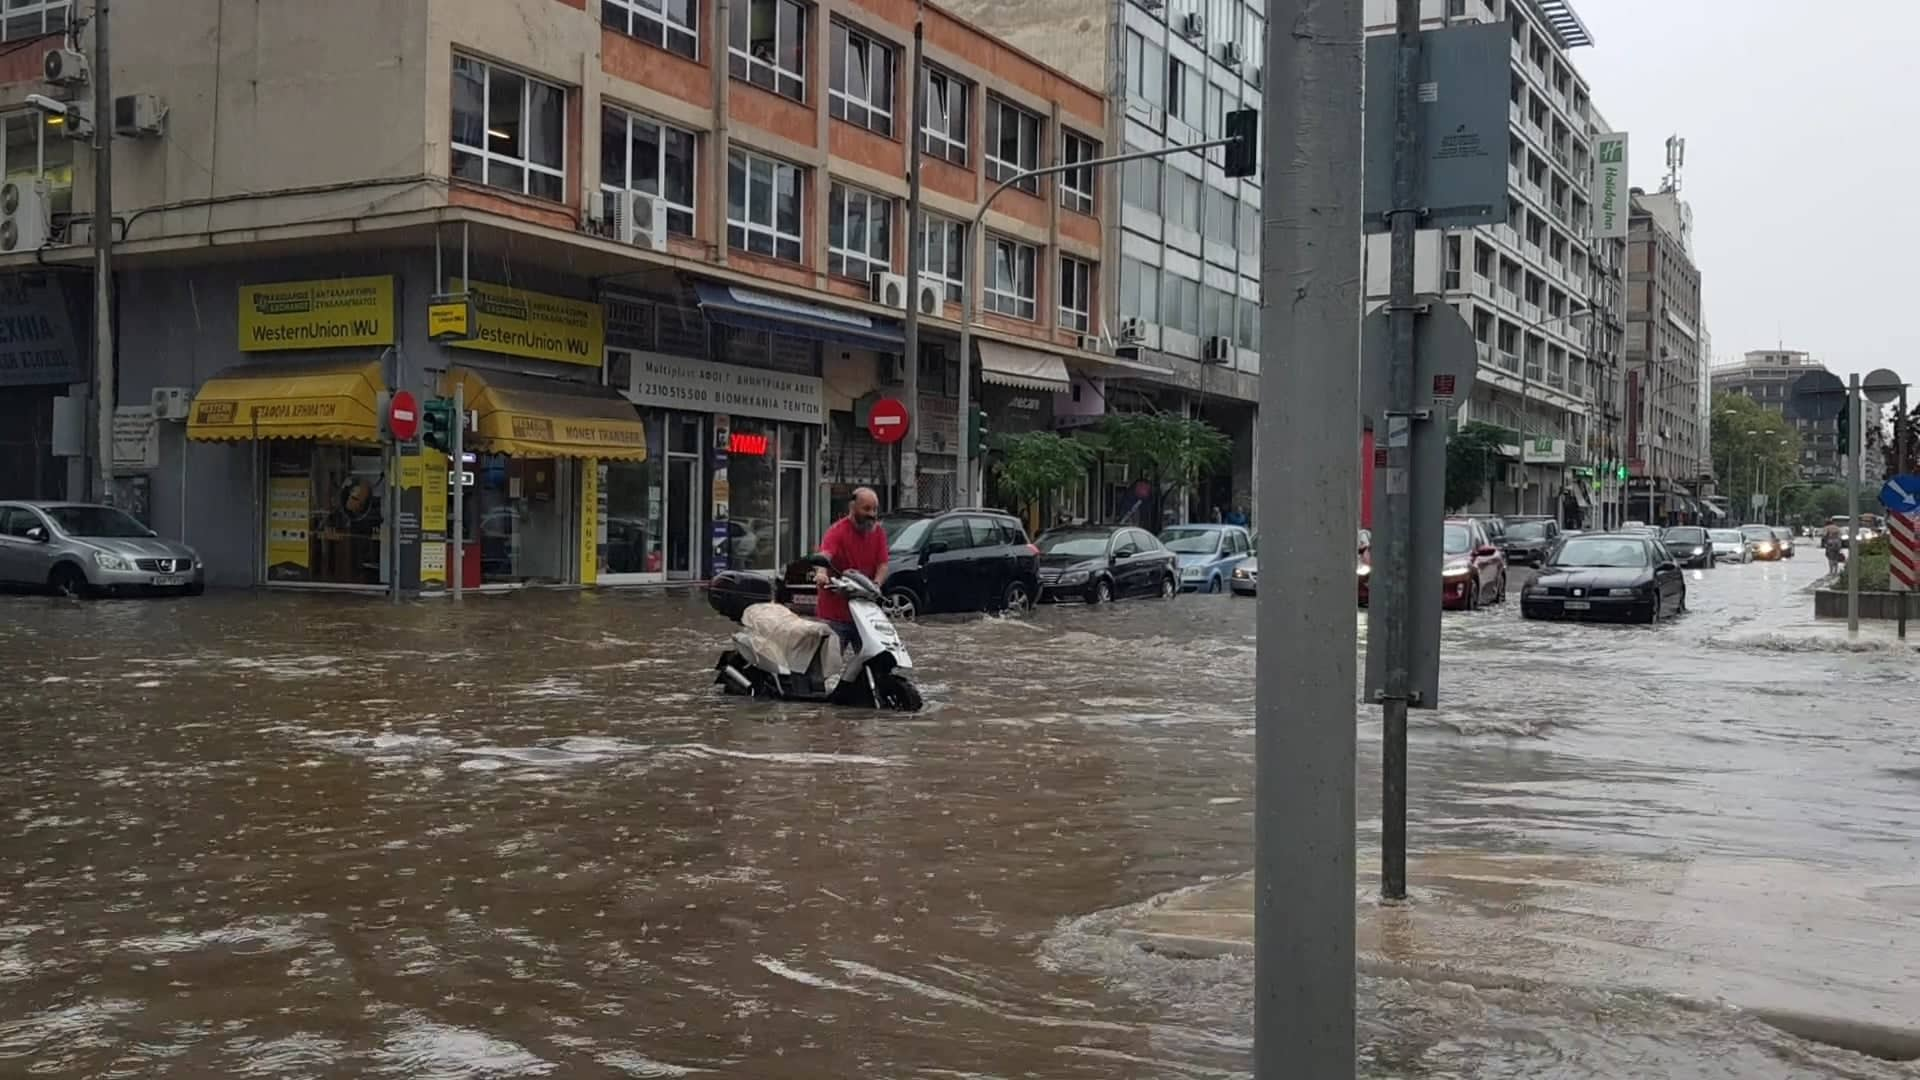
[1572, 0, 1920, 382]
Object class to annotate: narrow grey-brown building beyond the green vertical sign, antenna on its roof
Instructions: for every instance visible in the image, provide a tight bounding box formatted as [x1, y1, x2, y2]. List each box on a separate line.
[1626, 190, 1713, 523]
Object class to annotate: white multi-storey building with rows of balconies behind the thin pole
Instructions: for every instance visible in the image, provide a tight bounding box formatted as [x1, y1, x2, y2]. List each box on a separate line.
[1365, 0, 1605, 521]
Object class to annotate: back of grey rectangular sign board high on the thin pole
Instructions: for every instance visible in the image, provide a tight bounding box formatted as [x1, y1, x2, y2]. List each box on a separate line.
[1361, 21, 1513, 233]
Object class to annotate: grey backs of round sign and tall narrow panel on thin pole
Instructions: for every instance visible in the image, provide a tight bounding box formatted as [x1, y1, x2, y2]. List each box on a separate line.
[1359, 294, 1480, 709]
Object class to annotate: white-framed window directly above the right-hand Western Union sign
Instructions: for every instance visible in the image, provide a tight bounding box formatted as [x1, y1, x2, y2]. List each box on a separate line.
[453, 56, 566, 202]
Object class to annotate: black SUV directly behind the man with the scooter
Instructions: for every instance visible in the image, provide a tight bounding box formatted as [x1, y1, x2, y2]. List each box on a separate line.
[879, 509, 1041, 619]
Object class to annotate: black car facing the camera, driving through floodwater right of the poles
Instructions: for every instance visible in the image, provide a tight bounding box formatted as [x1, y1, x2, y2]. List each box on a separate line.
[1521, 532, 1686, 623]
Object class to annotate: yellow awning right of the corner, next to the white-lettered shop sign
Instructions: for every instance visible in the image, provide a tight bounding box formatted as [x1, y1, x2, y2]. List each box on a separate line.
[447, 367, 647, 461]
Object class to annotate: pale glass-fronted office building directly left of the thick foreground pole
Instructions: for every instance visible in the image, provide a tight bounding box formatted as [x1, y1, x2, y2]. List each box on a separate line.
[948, 0, 1271, 513]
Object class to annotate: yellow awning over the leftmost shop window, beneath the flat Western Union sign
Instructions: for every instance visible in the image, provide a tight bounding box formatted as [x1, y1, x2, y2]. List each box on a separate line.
[186, 359, 384, 442]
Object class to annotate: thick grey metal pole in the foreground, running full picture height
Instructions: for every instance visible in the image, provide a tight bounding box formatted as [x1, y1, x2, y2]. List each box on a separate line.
[1254, 0, 1371, 1080]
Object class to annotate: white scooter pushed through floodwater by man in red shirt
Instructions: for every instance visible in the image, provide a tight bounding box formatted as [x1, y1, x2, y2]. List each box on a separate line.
[707, 559, 922, 713]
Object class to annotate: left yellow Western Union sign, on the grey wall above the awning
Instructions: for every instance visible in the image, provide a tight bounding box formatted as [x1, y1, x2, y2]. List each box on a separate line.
[240, 275, 394, 352]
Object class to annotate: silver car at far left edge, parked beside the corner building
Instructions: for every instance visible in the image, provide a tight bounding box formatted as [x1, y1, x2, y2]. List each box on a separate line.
[0, 502, 207, 596]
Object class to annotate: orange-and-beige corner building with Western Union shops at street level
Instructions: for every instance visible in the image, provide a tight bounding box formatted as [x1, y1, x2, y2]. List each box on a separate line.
[0, 0, 1158, 588]
